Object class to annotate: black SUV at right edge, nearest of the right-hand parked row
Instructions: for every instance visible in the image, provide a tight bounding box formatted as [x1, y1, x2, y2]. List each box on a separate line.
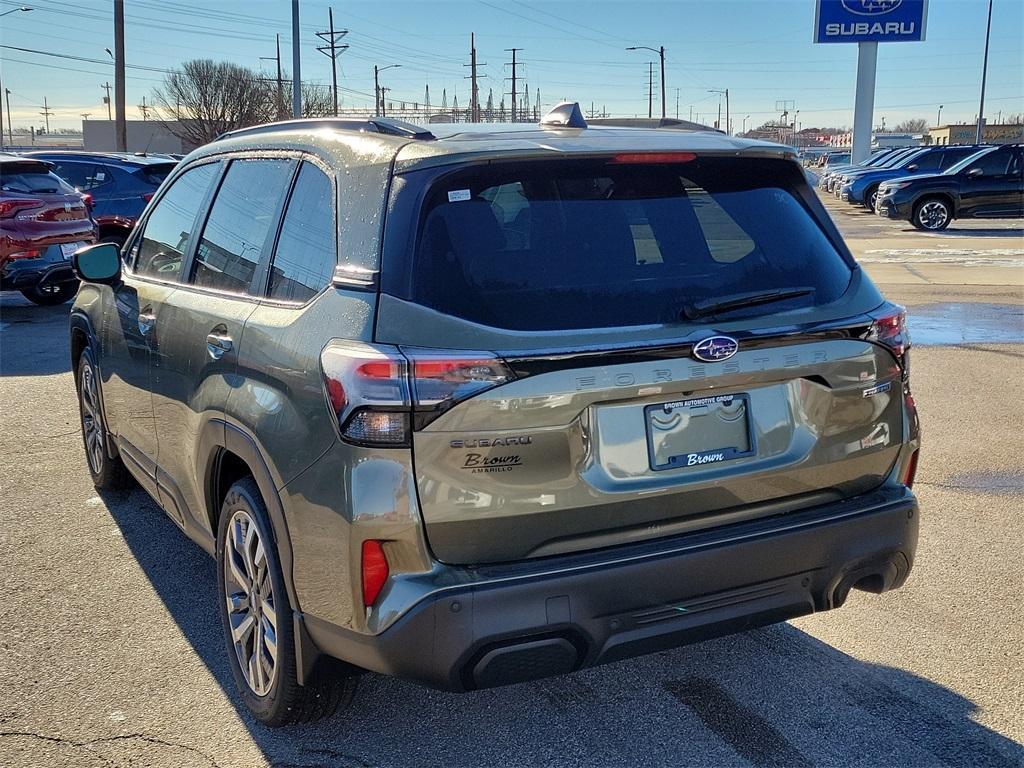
[874, 144, 1024, 231]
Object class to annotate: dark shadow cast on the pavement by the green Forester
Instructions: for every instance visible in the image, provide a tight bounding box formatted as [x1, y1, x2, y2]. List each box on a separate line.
[101, 489, 1024, 768]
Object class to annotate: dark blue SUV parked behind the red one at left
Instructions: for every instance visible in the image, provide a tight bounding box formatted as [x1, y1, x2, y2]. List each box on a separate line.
[26, 152, 178, 246]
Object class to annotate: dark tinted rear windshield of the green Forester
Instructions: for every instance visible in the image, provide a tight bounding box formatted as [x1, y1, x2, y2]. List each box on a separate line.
[393, 158, 852, 331]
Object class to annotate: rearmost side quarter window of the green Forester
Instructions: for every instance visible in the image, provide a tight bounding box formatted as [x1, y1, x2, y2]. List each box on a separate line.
[267, 163, 338, 303]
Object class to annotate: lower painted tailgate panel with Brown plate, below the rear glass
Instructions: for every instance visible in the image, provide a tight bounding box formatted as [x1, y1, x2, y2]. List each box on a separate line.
[413, 339, 902, 562]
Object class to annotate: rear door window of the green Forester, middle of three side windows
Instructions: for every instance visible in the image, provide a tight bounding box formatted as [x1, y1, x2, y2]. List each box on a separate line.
[191, 160, 295, 293]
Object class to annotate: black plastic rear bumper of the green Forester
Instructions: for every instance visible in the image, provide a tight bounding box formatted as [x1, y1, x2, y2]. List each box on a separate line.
[302, 486, 919, 691]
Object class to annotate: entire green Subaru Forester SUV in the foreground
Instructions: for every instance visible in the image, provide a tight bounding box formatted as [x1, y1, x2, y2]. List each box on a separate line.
[71, 104, 919, 724]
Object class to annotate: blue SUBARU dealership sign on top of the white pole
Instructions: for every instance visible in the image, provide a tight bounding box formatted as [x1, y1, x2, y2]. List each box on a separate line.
[814, 0, 928, 43]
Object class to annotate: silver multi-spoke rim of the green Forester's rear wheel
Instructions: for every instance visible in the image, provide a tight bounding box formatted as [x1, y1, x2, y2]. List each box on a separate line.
[223, 509, 278, 696]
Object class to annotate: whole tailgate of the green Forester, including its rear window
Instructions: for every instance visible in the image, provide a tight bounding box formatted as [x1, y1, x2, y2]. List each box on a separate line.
[375, 153, 903, 563]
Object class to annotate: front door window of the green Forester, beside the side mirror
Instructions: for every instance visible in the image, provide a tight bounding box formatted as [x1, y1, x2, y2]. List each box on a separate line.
[134, 163, 220, 281]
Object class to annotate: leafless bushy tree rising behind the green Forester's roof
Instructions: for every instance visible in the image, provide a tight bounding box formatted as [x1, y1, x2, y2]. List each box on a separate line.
[153, 58, 275, 146]
